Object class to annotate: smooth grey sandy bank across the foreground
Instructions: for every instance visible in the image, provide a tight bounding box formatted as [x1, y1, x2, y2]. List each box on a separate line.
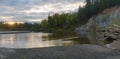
[0, 44, 120, 59]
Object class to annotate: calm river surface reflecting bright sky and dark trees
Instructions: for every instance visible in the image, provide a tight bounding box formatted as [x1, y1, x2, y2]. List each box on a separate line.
[0, 33, 106, 48]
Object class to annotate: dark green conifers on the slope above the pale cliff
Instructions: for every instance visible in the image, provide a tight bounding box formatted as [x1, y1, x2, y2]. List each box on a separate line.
[78, 0, 120, 23]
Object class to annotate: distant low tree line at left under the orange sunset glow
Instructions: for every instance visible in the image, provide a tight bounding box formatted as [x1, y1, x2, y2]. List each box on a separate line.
[0, 22, 41, 31]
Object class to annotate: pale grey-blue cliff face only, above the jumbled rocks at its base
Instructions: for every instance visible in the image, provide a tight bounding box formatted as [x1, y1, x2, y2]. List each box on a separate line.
[76, 6, 120, 33]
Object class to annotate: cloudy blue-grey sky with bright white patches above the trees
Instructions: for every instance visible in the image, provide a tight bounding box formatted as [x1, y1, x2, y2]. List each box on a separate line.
[0, 0, 85, 22]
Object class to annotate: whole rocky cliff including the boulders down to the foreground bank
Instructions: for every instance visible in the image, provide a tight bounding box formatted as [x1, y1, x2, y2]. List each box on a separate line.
[75, 6, 120, 50]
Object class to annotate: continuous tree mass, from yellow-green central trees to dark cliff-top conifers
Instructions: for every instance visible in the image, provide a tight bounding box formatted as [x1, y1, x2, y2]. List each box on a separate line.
[41, 0, 120, 31]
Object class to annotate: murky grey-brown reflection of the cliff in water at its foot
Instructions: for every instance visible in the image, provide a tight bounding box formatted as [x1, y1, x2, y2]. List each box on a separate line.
[81, 31, 110, 46]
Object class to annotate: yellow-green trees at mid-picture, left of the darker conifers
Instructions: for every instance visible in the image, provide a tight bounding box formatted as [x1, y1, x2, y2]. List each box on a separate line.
[41, 13, 78, 32]
